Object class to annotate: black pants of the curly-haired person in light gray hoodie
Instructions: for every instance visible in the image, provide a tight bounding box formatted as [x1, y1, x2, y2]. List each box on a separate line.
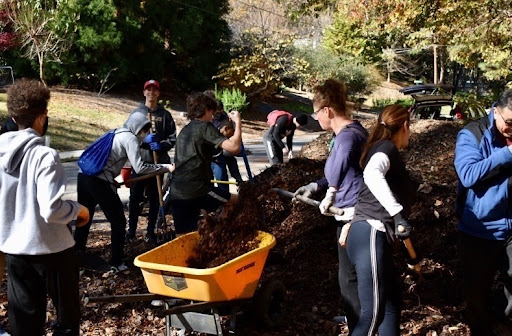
[6, 248, 80, 336]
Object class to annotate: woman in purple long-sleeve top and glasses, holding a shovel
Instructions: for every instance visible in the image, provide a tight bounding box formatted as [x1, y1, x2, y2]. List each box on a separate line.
[295, 79, 368, 328]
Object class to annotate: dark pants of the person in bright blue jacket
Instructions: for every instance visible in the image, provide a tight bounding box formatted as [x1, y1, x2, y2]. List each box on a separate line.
[459, 232, 512, 336]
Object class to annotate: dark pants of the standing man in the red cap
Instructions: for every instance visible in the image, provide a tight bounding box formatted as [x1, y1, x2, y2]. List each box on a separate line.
[128, 169, 160, 236]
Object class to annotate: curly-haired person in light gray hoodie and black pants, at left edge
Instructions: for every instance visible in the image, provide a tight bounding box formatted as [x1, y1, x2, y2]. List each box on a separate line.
[0, 79, 89, 336]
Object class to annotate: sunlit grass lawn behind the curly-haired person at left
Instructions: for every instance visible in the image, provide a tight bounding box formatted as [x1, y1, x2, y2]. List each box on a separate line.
[0, 92, 132, 151]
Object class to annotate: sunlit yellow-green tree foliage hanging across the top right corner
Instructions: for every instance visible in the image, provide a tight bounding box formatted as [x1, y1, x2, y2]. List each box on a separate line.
[326, 0, 512, 83]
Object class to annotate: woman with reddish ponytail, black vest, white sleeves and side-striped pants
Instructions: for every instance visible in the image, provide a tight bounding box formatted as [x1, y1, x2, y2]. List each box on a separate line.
[346, 105, 416, 336]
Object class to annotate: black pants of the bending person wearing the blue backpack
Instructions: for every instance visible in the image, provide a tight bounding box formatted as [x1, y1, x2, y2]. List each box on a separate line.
[75, 173, 126, 266]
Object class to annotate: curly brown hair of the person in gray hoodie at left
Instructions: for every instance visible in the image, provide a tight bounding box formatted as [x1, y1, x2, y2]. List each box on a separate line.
[7, 78, 50, 128]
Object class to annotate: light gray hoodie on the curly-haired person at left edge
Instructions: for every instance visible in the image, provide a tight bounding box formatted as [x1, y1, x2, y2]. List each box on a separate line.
[0, 128, 80, 255]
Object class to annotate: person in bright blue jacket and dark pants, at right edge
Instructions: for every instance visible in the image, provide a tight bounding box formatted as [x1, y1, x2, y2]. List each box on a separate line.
[454, 90, 512, 335]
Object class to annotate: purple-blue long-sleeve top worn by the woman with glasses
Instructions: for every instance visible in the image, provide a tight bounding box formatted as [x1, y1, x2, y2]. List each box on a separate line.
[317, 121, 368, 208]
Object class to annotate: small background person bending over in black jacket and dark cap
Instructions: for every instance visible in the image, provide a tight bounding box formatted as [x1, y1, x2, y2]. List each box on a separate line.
[263, 114, 308, 165]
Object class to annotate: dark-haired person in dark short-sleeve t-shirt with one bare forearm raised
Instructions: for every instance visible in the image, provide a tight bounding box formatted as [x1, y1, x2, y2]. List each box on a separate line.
[171, 92, 242, 235]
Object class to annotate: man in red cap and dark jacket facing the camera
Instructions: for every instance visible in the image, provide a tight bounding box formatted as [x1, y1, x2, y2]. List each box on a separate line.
[126, 79, 176, 244]
